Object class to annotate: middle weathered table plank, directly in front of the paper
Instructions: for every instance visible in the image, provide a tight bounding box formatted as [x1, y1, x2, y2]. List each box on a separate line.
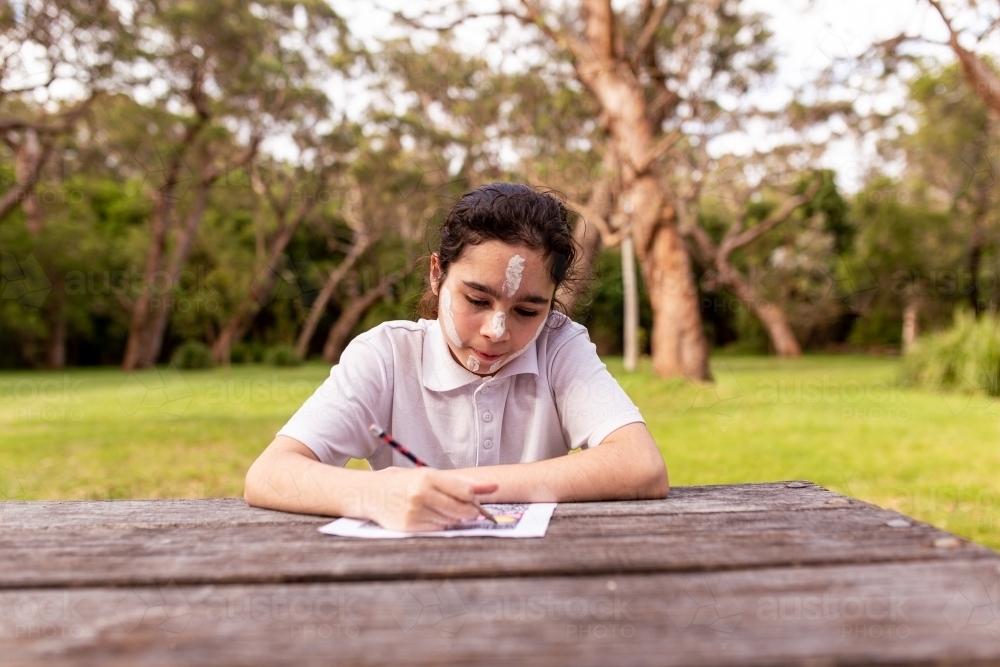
[0, 506, 997, 588]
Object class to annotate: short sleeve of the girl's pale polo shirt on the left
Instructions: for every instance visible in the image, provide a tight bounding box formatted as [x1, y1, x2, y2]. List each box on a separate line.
[278, 337, 392, 466]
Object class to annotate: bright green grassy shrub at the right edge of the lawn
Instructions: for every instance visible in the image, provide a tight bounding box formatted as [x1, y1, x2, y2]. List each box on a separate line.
[900, 311, 1000, 396]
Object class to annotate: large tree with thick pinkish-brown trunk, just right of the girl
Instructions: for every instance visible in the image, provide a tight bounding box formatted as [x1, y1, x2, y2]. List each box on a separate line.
[398, 0, 770, 379]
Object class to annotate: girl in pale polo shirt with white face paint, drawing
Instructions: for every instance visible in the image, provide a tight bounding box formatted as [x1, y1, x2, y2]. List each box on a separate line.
[244, 183, 669, 531]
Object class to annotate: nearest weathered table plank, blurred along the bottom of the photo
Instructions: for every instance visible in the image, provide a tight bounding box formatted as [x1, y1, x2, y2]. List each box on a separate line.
[0, 558, 1000, 667]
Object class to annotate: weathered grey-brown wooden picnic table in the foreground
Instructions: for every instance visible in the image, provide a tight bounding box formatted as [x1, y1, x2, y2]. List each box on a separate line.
[0, 482, 1000, 667]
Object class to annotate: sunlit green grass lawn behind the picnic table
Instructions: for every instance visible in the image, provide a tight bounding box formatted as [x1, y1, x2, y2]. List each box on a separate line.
[0, 356, 1000, 549]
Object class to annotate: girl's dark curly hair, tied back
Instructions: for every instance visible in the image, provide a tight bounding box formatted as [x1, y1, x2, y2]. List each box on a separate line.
[417, 183, 582, 319]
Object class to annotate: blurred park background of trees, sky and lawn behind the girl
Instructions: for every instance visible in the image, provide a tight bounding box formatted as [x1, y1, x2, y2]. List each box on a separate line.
[0, 0, 1000, 547]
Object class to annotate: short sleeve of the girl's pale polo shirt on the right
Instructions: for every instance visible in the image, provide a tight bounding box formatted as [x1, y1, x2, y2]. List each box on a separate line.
[549, 323, 645, 449]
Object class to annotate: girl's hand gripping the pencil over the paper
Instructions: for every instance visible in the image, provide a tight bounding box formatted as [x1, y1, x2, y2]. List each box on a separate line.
[366, 467, 497, 532]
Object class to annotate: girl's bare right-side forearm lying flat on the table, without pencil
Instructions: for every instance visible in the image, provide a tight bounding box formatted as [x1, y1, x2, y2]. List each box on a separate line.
[450, 422, 670, 502]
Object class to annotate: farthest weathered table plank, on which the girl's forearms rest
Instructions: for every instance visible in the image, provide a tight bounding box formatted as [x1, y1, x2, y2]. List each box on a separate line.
[0, 482, 864, 531]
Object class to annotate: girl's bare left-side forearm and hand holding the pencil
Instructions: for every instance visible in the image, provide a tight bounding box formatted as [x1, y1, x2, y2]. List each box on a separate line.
[243, 435, 496, 531]
